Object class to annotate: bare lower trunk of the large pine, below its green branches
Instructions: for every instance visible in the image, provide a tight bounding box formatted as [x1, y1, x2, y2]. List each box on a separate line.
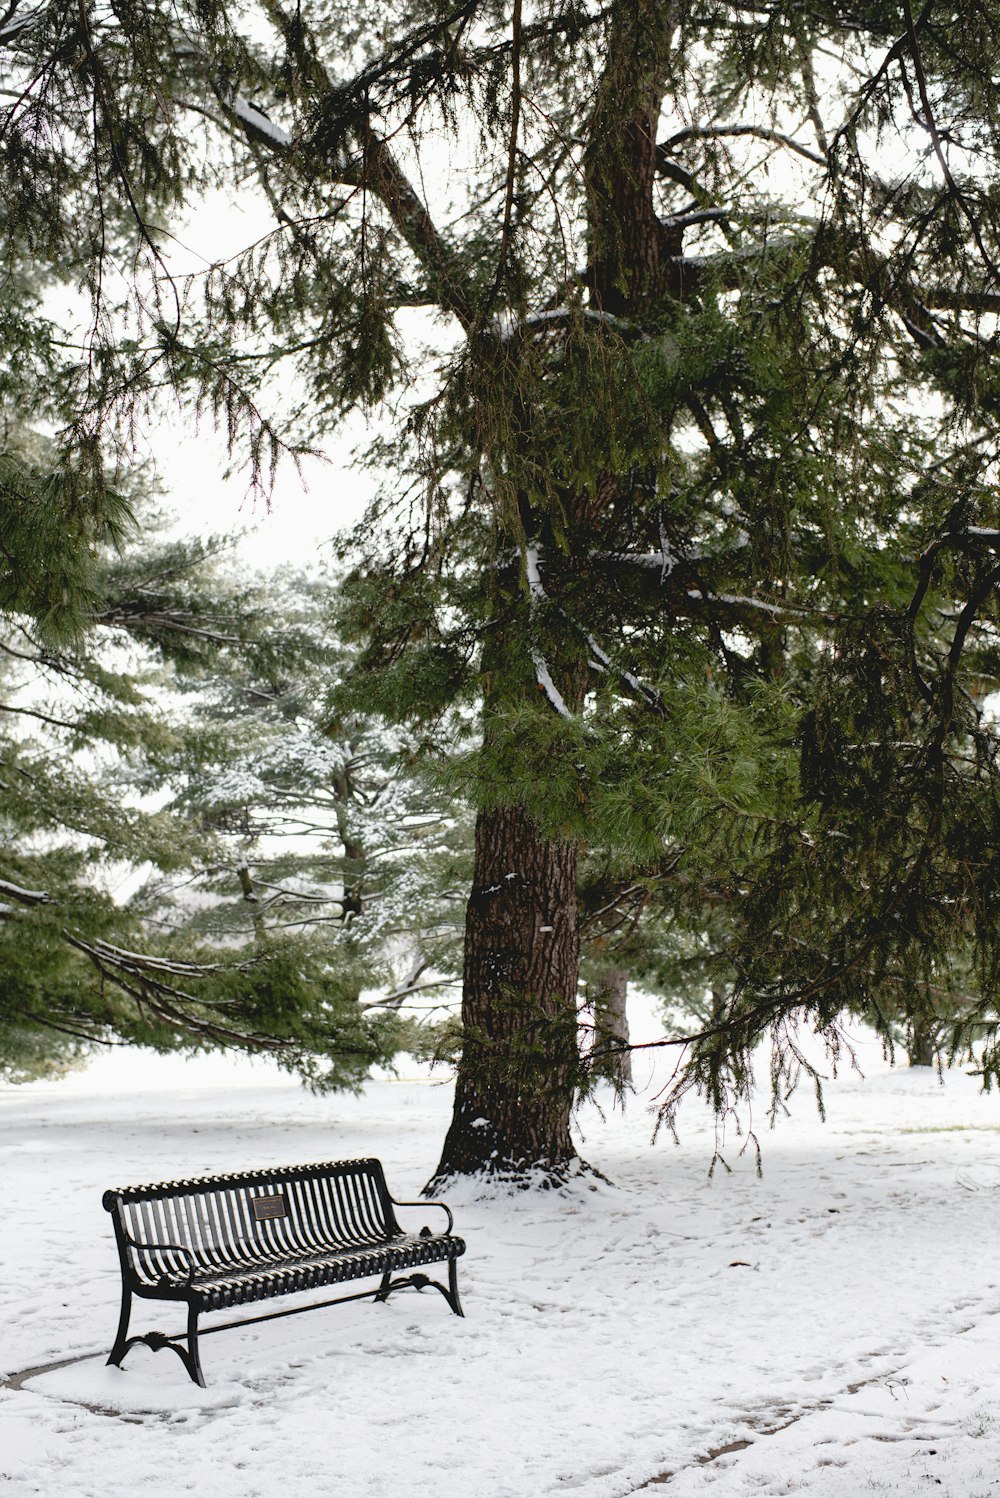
[428, 806, 579, 1189]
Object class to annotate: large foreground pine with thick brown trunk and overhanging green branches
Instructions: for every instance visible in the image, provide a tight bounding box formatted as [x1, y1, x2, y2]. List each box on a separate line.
[1, 0, 1000, 1180]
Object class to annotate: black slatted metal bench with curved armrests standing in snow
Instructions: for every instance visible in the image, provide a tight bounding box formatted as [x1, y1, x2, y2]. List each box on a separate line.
[102, 1159, 466, 1387]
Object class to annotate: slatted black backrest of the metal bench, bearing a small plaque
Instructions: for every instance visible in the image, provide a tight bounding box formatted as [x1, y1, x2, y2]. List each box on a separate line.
[102, 1159, 400, 1284]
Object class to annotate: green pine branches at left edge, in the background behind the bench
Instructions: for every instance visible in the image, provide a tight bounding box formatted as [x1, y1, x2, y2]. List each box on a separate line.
[0, 475, 407, 1088]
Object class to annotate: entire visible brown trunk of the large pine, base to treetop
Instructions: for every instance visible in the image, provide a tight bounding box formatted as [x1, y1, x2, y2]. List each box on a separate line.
[428, 0, 680, 1189]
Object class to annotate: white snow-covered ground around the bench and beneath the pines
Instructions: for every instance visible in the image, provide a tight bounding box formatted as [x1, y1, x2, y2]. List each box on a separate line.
[0, 1018, 1000, 1498]
